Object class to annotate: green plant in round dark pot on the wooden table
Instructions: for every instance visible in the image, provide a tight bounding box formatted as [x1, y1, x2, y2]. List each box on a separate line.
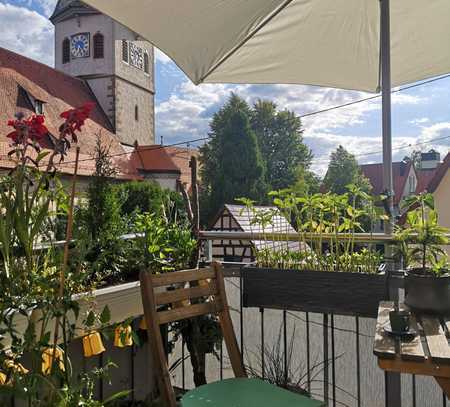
[396, 193, 450, 313]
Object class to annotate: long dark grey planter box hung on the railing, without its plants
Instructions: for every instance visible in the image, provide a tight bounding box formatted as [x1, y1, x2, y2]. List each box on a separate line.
[242, 267, 388, 318]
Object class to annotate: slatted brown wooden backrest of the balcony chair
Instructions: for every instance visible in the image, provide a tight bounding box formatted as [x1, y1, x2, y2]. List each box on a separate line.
[140, 263, 246, 407]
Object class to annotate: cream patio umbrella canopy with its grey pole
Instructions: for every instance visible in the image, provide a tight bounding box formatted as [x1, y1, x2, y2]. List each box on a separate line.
[84, 0, 450, 231]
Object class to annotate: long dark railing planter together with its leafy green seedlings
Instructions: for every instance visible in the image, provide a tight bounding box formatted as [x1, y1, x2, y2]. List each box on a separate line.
[241, 186, 387, 317]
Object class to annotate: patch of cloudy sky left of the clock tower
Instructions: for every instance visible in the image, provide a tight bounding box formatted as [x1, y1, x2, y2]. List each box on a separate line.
[0, 3, 54, 65]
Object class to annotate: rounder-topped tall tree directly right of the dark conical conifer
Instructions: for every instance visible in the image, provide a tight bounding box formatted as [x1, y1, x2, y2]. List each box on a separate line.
[251, 100, 312, 190]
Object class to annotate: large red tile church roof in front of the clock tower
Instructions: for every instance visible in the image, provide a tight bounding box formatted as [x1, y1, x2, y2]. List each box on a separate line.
[0, 48, 137, 178]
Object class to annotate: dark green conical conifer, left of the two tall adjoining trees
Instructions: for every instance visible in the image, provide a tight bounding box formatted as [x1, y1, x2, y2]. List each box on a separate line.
[200, 94, 267, 220]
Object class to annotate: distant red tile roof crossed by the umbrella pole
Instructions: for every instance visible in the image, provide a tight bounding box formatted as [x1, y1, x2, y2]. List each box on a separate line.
[360, 161, 412, 205]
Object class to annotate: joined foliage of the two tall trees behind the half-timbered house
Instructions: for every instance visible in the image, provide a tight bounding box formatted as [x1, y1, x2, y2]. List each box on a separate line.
[200, 94, 318, 225]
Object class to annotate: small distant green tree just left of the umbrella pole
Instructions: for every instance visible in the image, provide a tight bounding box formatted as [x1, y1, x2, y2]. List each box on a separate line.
[323, 146, 371, 194]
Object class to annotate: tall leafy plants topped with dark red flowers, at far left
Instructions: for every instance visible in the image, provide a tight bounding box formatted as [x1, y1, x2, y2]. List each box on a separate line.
[0, 105, 130, 406]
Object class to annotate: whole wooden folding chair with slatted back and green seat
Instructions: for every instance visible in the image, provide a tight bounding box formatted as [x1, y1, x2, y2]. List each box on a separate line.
[140, 263, 323, 407]
